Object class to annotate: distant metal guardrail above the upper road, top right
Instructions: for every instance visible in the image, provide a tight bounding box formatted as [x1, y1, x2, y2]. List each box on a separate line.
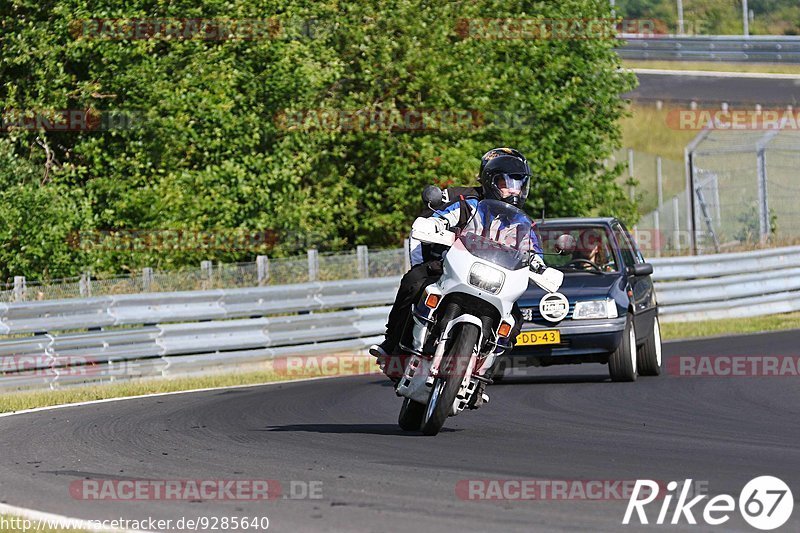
[618, 34, 800, 63]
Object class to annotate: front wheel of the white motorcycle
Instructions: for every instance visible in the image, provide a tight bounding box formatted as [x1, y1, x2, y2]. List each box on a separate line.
[422, 323, 480, 436]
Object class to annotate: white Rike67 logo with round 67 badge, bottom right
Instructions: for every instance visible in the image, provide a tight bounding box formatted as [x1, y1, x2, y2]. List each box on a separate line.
[622, 476, 794, 531]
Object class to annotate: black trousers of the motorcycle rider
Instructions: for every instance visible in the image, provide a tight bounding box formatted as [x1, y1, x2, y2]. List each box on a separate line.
[386, 260, 522, 350]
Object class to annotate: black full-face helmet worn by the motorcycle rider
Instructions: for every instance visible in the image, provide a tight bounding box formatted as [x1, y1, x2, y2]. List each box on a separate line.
[478, 148, 531, 207]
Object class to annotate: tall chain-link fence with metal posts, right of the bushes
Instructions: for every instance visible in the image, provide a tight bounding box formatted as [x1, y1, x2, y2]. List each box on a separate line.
[638, 122, 800, 255]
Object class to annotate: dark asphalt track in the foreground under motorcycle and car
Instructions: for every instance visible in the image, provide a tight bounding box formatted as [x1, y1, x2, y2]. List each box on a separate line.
[0, 331, 800, 531]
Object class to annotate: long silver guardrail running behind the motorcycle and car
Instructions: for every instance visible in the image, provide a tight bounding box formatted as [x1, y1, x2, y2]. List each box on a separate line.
[0, 246, 800, 390]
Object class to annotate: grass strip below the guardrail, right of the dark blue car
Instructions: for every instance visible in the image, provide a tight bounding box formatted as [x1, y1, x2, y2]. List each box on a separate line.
[661, 313, 800, 340]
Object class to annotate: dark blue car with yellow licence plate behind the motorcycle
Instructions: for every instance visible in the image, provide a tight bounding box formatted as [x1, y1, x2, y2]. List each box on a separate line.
[494, 218, 661, 381]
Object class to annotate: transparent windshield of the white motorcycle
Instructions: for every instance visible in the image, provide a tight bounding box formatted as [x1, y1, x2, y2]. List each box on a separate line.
[458, 200, 531, 270]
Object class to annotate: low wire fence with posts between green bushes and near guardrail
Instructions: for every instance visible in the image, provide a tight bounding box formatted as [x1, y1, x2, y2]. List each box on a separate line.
[0, 246, 408, 302]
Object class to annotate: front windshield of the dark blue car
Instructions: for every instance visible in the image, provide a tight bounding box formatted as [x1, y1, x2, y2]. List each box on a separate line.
[539, 224, 619, 273]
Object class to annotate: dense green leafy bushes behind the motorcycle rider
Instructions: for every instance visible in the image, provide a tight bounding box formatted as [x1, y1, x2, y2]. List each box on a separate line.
[0, 0, 636, 278]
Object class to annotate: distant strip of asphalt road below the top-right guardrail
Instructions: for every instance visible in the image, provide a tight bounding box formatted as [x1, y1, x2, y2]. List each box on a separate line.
[623, 74, 800, 107]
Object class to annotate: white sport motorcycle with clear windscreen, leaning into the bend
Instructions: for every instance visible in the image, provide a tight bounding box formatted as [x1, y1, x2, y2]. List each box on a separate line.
[386, 189, 564, 435]
